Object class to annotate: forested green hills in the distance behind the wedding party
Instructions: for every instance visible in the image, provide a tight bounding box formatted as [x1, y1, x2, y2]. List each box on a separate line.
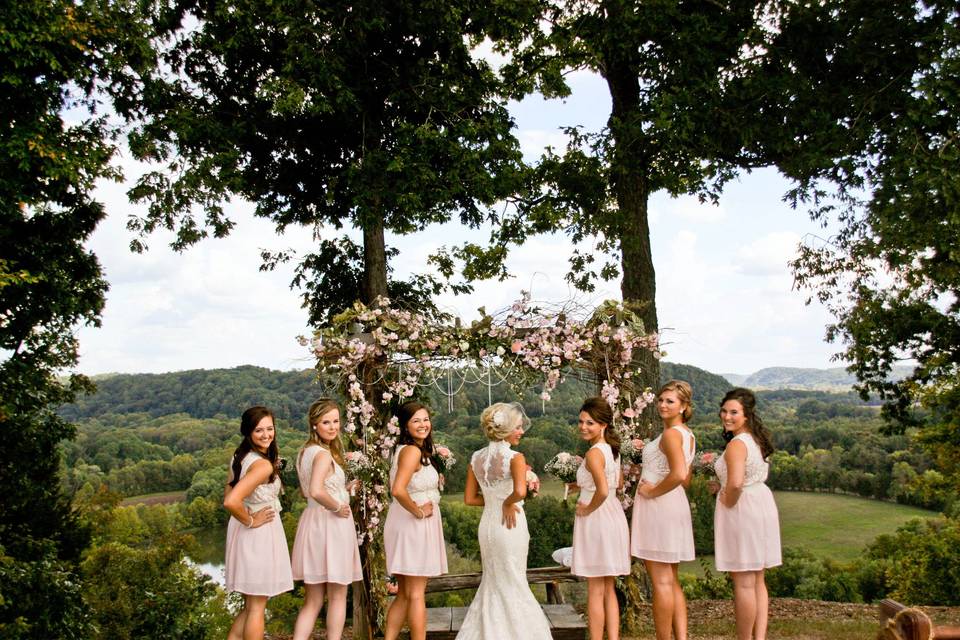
[61, 363, 949, 508]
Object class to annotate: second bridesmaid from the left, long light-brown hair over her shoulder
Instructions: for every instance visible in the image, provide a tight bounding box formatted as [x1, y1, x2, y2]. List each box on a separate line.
[292, 398, 363, 640]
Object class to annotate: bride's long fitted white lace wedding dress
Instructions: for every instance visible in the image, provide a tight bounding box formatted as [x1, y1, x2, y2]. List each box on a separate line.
[457, 441, 552, 640]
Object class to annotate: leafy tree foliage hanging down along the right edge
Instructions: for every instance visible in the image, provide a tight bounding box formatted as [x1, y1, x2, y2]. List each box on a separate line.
[793, 2, 960, 479]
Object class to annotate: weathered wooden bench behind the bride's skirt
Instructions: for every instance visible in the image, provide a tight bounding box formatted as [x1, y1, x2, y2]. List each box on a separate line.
[427, 567, 587, 640]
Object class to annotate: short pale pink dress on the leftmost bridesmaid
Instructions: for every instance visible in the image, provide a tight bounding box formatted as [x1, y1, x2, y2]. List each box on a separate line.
[225, 451, 293, 596]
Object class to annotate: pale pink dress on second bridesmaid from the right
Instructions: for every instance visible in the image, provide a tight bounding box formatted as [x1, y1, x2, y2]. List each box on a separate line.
[630, 425, 696, 564]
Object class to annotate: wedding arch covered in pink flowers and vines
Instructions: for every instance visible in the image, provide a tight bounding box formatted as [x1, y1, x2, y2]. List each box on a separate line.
[304, 293, 660, 637]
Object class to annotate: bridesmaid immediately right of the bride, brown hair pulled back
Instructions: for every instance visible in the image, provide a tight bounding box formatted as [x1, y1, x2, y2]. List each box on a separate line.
[570, 397, 630, 640]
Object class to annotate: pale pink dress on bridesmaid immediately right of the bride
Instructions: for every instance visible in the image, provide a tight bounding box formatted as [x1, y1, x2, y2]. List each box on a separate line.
[570, 442, 630, 578]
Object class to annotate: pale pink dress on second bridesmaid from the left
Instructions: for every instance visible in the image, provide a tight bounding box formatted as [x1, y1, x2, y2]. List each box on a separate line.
[291, 444, 363, 584]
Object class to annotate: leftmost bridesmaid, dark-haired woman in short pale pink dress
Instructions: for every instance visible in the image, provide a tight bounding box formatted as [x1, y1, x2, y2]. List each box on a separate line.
[223, 406, 293, 640]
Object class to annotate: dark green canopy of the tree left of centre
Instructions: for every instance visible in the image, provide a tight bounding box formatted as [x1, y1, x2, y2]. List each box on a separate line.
[115, 0, 525, 324]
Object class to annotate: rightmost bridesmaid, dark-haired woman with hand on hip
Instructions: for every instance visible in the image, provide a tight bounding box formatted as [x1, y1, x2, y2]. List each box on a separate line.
[713, 388, 781, 640]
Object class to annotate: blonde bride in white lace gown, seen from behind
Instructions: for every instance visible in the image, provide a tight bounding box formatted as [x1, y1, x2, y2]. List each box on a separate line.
[457, 402, 552, 640]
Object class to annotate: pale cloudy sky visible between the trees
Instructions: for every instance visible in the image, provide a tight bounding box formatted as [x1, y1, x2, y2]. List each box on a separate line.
[78, 72, 839, 375]
